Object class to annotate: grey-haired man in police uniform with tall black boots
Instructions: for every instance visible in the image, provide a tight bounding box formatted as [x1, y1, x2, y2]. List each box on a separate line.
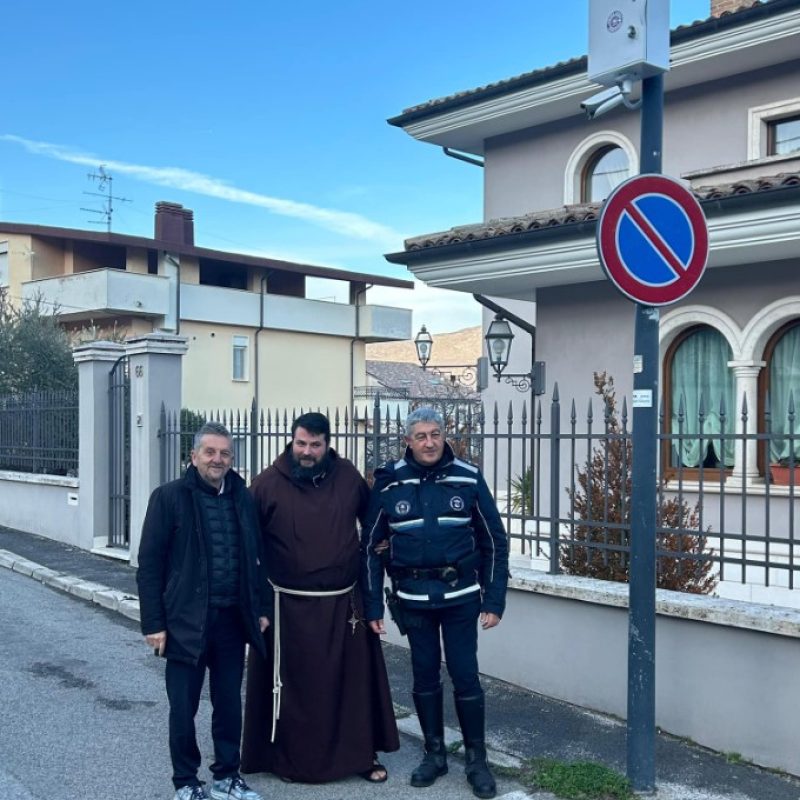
[362, 408, 508, 798]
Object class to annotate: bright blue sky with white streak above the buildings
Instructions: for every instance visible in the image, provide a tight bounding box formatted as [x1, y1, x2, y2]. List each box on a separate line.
[0, 0, 709, 332]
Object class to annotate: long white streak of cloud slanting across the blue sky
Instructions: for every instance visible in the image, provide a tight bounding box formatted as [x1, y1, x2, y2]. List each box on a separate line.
[0, 134, 403, 250]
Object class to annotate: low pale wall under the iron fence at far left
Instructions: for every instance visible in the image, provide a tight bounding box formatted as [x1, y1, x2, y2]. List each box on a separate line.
[0, 470, 80, 546]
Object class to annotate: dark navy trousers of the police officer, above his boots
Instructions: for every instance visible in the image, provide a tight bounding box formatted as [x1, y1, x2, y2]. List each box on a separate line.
[406, 592, 481, 697]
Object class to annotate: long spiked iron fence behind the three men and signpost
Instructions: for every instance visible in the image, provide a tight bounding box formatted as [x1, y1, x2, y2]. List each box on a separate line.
[160, 389, 800, 592]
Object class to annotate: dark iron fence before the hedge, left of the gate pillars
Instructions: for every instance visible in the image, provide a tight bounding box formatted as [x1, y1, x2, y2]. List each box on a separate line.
[0, 391, 78, 475]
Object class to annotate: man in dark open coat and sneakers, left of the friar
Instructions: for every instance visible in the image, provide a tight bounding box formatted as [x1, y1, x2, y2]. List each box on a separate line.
[136, 422, 271, 800]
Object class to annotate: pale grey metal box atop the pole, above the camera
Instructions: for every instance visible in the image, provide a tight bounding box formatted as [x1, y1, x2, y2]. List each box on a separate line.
[588, 0, 669, 86]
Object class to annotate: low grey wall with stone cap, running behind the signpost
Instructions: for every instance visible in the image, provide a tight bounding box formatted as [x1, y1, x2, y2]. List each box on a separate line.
[388, 567, 800, 775]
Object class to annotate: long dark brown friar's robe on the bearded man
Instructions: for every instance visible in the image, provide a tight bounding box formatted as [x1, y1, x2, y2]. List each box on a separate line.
[241, 448, 400, 783]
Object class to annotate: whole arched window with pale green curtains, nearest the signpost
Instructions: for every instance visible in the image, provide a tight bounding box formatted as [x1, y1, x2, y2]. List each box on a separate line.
[664, 325, 736, 469]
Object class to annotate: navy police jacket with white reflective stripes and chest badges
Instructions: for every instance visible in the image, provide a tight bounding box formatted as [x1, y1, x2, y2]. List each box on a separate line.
[362, 444, 508, 621]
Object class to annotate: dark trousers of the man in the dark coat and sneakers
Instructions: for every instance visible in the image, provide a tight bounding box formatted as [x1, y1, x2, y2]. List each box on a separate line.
[165, 608, 245, 789]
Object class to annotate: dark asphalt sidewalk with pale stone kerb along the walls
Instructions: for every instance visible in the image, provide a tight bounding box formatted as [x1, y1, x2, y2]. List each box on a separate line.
[0, 527, 800, 800]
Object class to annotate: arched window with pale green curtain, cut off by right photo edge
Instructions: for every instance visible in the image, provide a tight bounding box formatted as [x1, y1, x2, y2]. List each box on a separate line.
[763, 320, 800, 463]
